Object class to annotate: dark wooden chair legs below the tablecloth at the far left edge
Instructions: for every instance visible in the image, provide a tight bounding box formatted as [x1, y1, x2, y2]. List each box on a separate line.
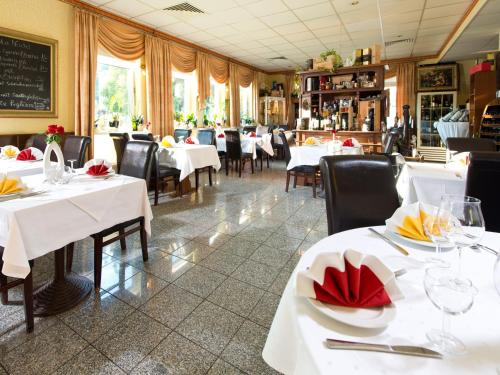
[0, 248, 35, 333]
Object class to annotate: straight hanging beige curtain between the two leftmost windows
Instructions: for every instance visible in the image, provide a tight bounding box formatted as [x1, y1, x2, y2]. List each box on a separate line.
[145, 35, 174, 137]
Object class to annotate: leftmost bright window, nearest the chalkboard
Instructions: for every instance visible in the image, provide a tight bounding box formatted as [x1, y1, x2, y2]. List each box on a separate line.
[95, 55, 141, 130]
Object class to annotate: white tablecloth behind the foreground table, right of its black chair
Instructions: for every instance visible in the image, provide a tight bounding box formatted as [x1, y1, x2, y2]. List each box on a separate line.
[397, 162, 467, 206]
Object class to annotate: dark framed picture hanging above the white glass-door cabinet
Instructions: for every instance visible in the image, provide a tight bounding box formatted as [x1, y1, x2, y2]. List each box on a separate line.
[417, 64, 458, 91]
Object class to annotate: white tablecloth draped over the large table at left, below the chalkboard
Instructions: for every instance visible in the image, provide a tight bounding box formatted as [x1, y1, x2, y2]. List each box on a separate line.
[0, 174, 153, 278]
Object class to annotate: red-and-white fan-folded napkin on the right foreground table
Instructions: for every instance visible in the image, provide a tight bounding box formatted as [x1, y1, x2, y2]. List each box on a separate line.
[297, 250, 403, 308]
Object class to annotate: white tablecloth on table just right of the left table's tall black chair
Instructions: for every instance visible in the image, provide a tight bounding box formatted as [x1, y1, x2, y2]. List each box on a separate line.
[158, 144, 221, 181]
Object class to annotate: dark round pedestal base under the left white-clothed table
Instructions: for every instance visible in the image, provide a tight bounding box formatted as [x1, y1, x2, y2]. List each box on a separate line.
[33, 247, 93, 316]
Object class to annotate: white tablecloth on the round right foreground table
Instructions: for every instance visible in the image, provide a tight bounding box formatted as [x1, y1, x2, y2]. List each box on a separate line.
[262, 227, 500, 375]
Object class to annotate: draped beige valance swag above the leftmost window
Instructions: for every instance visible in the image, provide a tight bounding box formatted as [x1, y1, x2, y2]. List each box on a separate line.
[98, 18, 144, 60]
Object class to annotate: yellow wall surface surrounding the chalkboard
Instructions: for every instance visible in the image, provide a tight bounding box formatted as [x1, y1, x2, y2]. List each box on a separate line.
[0, 0, 75, 134]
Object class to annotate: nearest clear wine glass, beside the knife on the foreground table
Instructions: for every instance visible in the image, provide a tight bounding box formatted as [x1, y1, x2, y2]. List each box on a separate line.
[424, 267, 478, 355]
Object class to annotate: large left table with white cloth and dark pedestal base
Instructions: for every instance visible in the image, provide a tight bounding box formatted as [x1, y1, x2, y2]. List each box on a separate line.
[0, 170, 153, 316]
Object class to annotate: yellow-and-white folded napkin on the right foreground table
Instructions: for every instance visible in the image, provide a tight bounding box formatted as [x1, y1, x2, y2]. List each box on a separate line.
[385, 202, 437, 241]
